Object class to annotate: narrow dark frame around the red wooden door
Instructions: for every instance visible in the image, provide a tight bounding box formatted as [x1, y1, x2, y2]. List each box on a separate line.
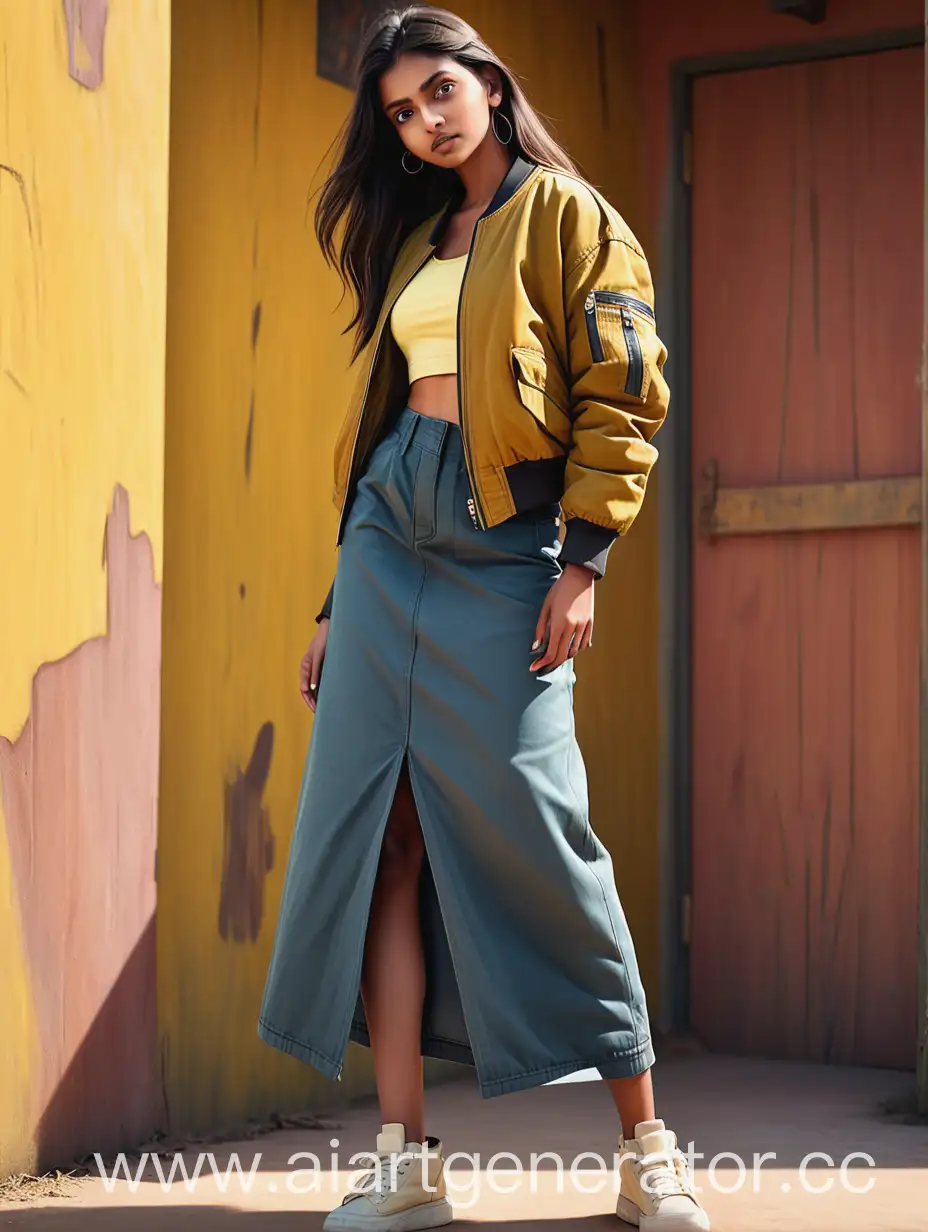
[656, 19, 928, 1039]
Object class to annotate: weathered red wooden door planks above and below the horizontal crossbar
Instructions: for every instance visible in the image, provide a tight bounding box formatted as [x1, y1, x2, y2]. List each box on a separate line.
[690, 48, 923, 1068]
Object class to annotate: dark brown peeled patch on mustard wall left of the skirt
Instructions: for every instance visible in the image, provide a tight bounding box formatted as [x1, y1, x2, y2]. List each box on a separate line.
[219, 722, 274, 941]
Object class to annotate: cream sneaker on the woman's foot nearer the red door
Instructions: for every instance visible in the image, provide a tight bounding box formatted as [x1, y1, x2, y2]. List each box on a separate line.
[615, 1121, 709, 1232]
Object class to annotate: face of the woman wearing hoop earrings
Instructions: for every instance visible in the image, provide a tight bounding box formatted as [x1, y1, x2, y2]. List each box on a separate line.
[380, 53, 503, 168]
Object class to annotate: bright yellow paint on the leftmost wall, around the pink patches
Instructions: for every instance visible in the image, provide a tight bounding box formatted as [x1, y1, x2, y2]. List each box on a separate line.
[0, 0, 170, 1175]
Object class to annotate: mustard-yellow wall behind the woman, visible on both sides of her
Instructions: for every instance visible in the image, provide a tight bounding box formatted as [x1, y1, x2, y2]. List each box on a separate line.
[158, 0, 657, 1127]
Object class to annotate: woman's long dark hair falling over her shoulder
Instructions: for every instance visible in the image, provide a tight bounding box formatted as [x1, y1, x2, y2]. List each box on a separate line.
[315, 5, 578, 361]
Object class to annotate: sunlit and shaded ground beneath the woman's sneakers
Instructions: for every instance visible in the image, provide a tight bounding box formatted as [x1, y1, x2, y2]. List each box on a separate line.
[0, 1055, 928, 1232]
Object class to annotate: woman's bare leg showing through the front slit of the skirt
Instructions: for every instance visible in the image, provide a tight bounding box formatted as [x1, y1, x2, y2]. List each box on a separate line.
[361, 765, 425, 1142]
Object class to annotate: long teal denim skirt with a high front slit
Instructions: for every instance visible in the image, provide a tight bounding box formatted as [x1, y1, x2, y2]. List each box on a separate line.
[258, 407, 654, 1098]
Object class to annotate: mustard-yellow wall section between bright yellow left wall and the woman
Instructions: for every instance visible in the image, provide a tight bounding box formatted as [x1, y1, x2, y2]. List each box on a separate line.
[158, 0, 349, 1127]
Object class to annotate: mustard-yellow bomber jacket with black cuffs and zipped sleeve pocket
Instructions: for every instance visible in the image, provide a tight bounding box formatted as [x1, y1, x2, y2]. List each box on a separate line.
[320, 156, 669, 617]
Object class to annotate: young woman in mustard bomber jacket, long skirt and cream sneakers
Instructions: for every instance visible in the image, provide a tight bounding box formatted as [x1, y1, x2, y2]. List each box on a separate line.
[259, 6, 709, 1232]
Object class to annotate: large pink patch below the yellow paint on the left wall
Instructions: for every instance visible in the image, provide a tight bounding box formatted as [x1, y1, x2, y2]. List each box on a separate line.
[0, 485, 164, 1169]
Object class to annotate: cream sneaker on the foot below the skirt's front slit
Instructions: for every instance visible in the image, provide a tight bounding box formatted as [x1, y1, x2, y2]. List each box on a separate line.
[323, 1122, 454, 1232]
